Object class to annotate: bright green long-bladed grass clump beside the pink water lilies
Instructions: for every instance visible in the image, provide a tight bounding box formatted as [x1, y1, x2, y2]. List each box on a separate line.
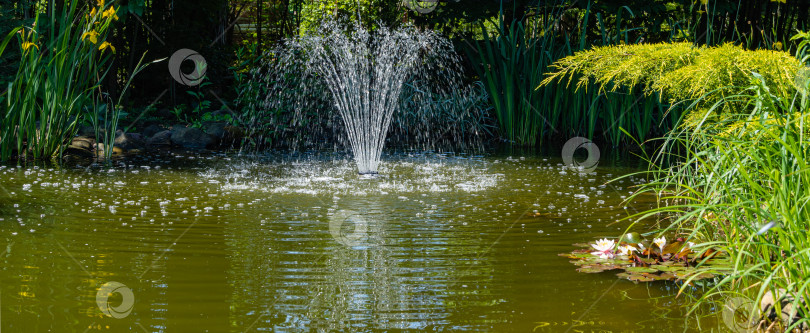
[624, 63, 810, 331]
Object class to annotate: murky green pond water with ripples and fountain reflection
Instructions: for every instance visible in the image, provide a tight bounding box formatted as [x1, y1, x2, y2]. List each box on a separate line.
[0, 153, 723, 332]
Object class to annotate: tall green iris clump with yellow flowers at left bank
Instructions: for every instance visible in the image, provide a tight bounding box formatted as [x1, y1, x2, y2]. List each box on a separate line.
[0, 0, 118, 161]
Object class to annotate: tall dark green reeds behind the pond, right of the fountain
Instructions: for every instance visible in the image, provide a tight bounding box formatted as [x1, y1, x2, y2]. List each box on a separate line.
[468, 2, 680, 146]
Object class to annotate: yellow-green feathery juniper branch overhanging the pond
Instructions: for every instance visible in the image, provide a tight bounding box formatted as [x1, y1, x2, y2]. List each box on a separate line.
[542, 43, 801, 130]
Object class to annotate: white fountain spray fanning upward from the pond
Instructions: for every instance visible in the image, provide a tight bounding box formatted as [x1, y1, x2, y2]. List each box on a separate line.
[249, 21, 458, 174]
